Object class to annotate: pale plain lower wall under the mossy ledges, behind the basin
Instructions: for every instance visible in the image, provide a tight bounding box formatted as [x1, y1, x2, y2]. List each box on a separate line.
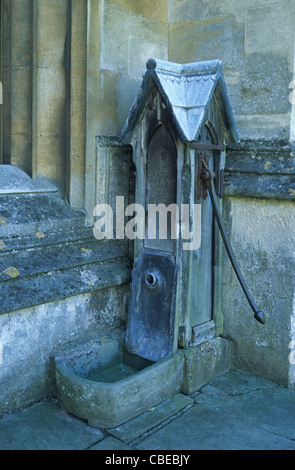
[0, 285, 129, 416]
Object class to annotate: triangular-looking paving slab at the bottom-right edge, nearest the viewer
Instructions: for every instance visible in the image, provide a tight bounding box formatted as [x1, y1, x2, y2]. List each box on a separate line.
[136, 405, 295, 451]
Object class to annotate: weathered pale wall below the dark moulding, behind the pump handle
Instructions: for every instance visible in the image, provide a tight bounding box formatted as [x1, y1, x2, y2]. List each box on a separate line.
[223, 194, 295, 386]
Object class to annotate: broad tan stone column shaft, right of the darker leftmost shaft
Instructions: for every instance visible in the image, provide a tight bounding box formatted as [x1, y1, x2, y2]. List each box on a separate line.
[32, 0, 68, 192]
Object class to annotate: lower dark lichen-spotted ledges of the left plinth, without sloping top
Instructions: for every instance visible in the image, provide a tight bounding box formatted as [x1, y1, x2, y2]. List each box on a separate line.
[0, 227, 131, 314]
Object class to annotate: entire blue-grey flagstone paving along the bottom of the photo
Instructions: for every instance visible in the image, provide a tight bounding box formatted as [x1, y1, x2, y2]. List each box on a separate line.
[0, 371, 295, 451]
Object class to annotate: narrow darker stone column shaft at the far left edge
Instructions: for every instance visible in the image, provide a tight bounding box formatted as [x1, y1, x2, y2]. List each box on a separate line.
[2, 0, 33, 174]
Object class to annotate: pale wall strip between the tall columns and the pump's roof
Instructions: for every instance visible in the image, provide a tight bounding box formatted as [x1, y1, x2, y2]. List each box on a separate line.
[100, 0, 168, 135]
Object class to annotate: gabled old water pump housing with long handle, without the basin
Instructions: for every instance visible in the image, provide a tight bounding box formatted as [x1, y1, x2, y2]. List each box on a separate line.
[121, 59, 264, 361]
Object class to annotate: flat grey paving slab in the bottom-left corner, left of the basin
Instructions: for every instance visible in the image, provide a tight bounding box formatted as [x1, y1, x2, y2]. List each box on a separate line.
[0, 401, 104, 450]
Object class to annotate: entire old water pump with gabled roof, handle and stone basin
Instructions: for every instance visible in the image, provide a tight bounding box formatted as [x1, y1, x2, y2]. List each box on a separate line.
[55, 59, 264, 428]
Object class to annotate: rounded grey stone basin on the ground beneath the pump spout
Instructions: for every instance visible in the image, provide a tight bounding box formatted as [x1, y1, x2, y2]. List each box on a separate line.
[55, 332, 184, 429]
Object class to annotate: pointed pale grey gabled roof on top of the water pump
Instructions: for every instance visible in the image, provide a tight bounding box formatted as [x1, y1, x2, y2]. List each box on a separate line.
[121, 59, 240, 144]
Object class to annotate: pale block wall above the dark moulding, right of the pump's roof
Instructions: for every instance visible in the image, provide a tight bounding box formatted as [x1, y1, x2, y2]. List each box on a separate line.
[169, 0, 295, 140]
